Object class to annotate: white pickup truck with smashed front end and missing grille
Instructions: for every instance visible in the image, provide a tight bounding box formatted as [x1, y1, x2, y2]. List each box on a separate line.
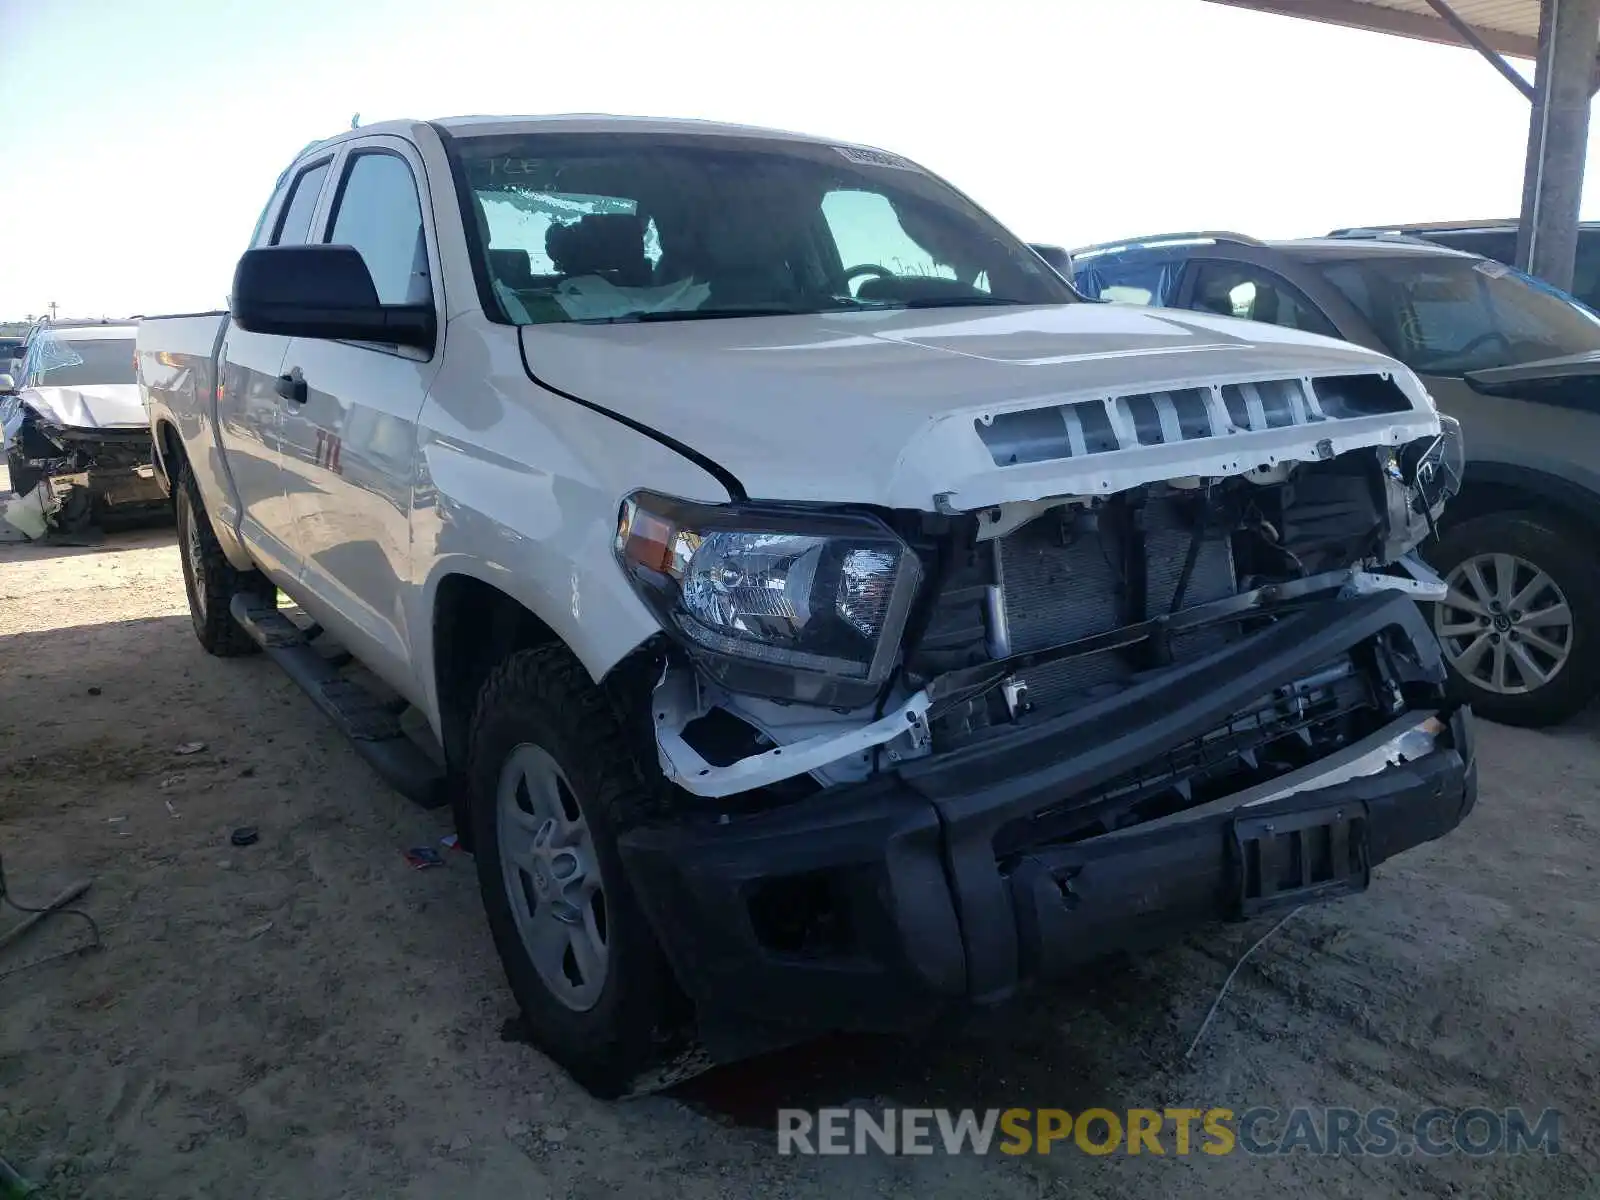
[138, 117, 1477, 1094]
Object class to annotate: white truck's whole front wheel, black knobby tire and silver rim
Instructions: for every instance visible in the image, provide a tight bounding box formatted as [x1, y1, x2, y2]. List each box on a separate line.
[467, 646, 688, 1098]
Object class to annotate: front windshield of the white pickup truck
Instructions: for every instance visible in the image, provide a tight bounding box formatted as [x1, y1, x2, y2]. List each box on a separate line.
[458, 134, 1078, 325]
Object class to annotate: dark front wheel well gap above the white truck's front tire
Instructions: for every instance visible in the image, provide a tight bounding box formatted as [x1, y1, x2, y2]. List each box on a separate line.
[434, 574, 560, 790]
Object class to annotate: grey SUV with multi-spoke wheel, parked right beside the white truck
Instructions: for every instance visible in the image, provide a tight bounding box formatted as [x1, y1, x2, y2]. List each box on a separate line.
[1072, 232, 1600, 726]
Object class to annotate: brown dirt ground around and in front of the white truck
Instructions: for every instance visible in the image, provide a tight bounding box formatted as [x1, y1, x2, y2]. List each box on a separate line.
[0, 531, 1600, 1200]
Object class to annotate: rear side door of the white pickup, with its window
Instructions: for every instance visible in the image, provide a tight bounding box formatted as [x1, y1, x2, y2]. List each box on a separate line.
[216, 154, 333, 582]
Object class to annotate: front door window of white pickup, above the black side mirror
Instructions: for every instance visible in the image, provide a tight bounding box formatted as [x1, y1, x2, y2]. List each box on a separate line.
[325, 152, 434, 304]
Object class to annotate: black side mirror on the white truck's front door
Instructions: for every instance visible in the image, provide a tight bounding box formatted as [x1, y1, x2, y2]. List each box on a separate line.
[229, 246, 437, 350]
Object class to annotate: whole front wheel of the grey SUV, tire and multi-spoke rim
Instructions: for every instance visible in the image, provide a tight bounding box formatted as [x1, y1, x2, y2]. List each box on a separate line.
[1427, 512, 1600, 726]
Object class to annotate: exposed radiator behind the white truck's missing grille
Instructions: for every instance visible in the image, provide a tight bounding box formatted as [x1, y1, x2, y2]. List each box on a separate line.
[995, 499, 1235, 707]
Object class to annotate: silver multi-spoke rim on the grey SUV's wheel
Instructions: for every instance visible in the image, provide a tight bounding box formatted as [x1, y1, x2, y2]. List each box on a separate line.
[1434, 554, 1573, 696]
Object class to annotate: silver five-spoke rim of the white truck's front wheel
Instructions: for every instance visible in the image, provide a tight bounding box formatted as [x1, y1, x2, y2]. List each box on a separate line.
[496, 746, 611, 1013]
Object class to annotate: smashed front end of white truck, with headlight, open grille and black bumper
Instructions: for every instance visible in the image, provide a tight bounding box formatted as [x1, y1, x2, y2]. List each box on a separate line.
[604, 366, 1474, 1049]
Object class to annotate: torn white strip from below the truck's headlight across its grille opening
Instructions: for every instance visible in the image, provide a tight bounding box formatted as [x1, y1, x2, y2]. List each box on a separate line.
[653, 555, 1445, 798]
